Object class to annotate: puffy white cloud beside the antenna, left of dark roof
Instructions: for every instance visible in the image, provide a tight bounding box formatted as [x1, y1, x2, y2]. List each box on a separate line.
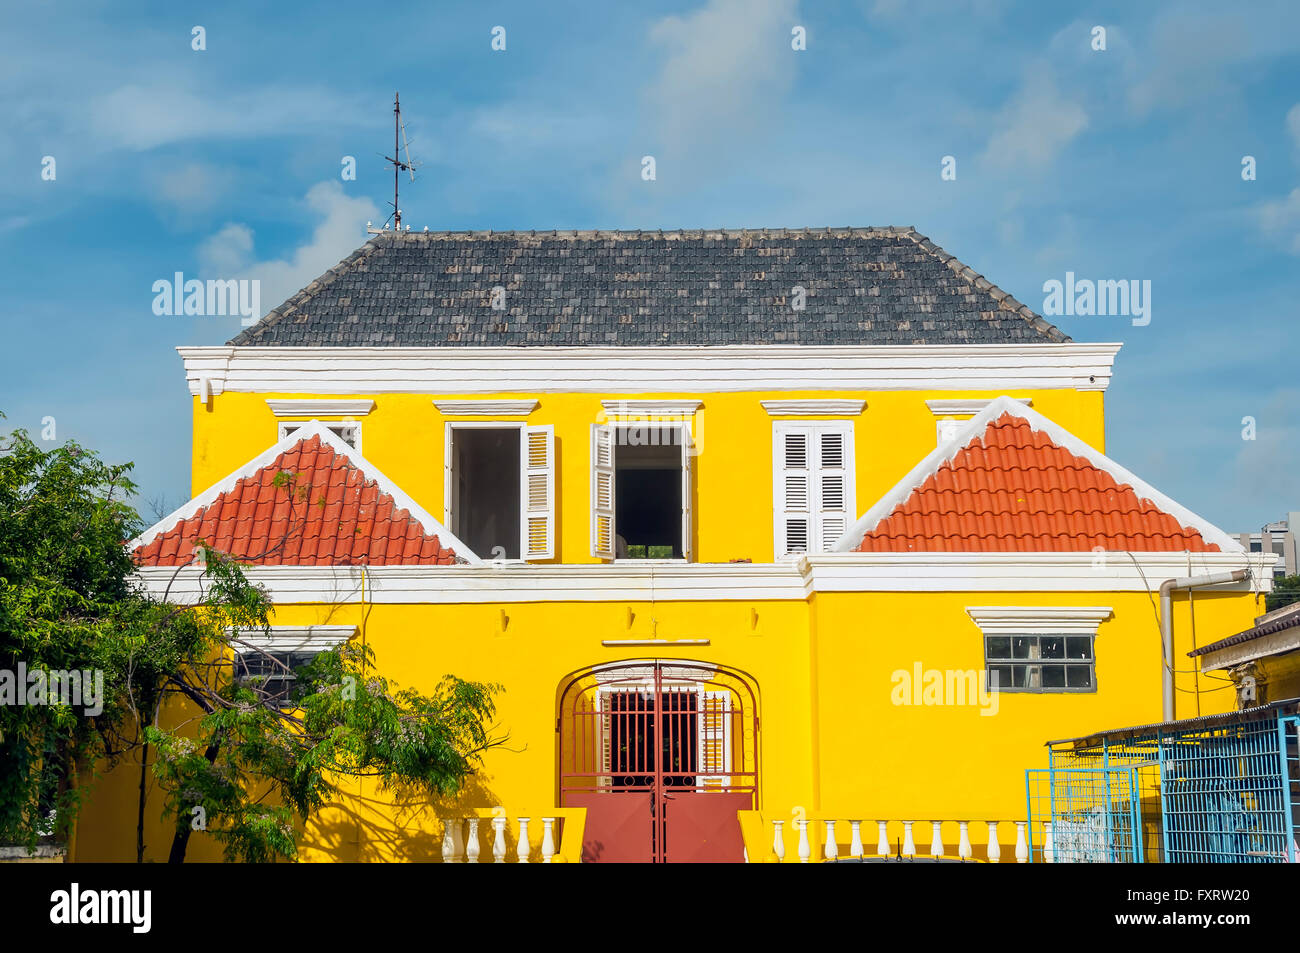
[199, 181, 380, 317]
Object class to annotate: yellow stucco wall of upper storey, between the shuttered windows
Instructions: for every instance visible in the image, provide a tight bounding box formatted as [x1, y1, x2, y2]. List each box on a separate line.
[191, 390, 1105, 563]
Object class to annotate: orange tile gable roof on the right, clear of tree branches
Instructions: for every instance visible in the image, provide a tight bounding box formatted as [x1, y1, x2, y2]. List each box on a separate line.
[854, 411, 1219, 553]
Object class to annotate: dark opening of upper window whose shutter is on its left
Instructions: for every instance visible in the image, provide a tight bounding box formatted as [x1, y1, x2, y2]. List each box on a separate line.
[614, 428, 683, 559]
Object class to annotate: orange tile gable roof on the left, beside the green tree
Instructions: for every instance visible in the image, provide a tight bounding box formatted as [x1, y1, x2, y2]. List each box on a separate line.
[135, 433, 458, 566]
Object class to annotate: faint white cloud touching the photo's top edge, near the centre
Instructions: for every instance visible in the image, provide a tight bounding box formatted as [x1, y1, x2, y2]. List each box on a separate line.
[646, 0, 795, 155]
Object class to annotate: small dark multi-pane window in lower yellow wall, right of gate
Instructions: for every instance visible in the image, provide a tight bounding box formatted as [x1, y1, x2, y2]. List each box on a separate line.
[984, 633, 1097, 692]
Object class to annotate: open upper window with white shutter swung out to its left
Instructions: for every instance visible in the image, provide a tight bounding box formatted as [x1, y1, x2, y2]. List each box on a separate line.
[592, 421, 693, 560]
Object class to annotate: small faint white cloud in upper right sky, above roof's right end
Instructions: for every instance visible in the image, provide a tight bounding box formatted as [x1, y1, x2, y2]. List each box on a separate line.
[983, 69, 1088, 169]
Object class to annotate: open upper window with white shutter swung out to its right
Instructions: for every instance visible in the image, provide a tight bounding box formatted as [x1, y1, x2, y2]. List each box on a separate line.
[446, 423, 555, 559]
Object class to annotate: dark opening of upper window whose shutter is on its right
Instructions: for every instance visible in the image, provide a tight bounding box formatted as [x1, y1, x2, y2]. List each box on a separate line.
[450, 428, 519, 559]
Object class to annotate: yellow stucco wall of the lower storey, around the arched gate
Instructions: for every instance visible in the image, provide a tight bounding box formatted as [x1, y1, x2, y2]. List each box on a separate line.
[65, 579, 1257, 861]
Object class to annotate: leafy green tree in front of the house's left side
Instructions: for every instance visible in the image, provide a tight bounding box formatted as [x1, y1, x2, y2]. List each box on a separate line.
[0, 421, 504, 861]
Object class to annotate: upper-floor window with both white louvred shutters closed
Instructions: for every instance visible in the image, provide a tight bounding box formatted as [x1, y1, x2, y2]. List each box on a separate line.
[772, 420, 858, 559]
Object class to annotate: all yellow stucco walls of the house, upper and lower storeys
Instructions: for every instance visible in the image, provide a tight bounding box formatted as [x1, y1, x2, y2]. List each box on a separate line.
[63, 390, 1261, 861]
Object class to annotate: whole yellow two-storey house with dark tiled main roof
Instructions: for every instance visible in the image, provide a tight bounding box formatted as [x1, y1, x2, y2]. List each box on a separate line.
[68, 229, 1268, 861]
